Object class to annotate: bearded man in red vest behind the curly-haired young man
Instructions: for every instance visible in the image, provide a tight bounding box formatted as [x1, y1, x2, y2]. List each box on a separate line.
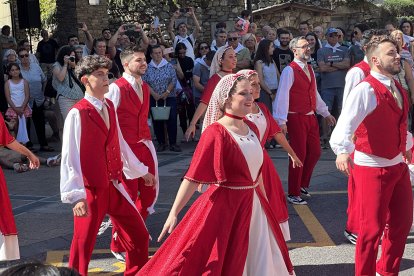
[105, 47, 159, 261]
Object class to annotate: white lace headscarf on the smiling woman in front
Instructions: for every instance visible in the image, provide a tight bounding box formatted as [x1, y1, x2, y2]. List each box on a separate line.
[201, 74, 247, 132]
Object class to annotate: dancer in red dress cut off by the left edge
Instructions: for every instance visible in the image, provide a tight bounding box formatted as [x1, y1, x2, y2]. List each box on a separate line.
[0, 115, 40, 261]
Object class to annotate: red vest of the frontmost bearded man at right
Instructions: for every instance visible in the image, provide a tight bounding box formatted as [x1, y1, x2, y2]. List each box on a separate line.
[355, 75, 408, 159]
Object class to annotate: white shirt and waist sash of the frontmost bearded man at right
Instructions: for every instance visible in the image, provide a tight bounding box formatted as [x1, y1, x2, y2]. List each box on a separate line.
[329, 71, 413, 167]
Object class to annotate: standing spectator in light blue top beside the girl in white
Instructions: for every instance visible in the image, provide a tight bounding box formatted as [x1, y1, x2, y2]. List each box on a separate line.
[18, 48, 54, 151]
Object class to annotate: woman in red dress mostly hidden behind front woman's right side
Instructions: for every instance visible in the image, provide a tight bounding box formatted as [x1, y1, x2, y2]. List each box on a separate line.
[238, 69, 302, 241]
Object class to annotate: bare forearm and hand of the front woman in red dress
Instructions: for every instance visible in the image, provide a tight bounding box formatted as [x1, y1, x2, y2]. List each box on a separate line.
[158, 179, 198, 242]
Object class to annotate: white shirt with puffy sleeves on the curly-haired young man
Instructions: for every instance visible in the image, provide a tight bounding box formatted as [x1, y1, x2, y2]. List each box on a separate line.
[60, 94, 148, 204]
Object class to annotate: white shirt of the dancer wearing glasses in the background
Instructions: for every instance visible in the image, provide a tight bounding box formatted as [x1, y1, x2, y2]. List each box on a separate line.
[273, 59, 331, 125]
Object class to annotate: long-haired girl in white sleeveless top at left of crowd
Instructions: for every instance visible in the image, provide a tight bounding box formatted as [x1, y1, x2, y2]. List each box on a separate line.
[4, 63, 32, 143]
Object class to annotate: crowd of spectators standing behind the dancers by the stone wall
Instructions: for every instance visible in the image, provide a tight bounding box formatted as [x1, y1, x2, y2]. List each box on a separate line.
[0, 11, 414, 157]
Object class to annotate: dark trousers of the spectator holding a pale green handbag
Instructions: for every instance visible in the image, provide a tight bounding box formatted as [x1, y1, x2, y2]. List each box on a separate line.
[150, 97, 177, 145]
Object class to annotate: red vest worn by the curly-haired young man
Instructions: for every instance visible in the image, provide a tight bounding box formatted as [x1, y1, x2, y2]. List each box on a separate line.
[73, 99, 123, 189]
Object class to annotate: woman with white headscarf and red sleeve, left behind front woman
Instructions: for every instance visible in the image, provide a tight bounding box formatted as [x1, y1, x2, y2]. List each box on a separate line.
[185, 46, 237, 141]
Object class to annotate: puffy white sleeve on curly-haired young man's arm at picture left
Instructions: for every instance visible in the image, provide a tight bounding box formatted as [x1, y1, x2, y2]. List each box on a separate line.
[60, 108, 86, 204]
